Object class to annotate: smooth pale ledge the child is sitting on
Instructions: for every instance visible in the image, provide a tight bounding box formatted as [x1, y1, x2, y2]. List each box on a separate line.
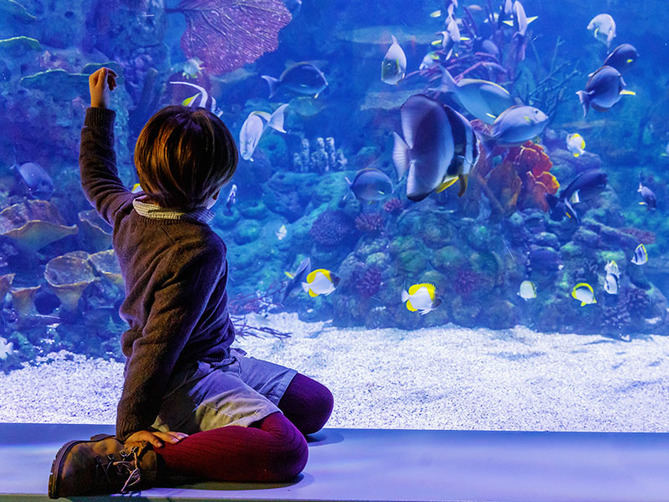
[0, 424, 669, 502]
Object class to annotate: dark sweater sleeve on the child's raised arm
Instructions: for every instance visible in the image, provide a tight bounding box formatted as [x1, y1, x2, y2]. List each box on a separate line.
[79, 108, 131, 226]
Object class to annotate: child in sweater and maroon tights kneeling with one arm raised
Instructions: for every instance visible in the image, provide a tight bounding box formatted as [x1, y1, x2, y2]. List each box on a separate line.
[49, 68, 333, 498]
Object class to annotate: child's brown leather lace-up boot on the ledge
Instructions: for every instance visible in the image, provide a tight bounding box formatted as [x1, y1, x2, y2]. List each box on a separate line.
[49, 434, 158, 499]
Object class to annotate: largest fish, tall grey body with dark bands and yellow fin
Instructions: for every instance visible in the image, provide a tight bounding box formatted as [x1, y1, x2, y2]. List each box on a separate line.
[393, 94, 480, 202]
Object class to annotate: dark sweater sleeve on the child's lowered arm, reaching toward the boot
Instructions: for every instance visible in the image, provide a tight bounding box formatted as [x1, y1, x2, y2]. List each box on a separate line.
[116, 248, 226, 442]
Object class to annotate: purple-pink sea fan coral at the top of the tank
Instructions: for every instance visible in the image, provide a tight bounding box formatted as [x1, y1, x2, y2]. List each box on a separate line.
[167, 0, 292, 75]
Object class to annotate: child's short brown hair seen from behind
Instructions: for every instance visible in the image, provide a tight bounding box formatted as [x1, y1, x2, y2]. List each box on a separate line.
[135, 105, 239, 211]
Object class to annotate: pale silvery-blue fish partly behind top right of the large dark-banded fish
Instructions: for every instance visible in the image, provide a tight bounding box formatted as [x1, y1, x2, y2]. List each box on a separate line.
[430, 65, 514, 124]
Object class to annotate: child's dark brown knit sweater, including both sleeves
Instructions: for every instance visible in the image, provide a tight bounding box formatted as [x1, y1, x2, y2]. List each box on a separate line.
[79, 108, 235, 441]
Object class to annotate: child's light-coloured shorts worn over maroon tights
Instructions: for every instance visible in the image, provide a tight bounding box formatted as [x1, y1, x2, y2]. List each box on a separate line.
[152, 348, 297, 434]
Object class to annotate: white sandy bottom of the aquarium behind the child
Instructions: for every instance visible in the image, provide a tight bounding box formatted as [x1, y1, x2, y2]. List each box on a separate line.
[0, 314, 669, 432]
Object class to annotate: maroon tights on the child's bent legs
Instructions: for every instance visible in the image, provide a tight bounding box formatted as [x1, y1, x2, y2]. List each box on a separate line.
[156, 373, 333, 482]
